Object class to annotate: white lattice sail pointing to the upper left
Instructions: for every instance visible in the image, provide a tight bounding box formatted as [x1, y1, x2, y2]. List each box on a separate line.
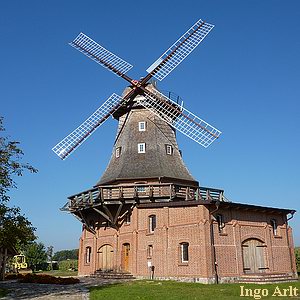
[69, 32, 133, 76]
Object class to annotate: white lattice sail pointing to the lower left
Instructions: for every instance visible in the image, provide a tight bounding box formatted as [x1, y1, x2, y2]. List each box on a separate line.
[52, 93, 124, 160]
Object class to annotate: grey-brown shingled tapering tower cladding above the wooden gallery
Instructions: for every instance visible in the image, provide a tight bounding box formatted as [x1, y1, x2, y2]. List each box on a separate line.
[96, 86, 198, 185]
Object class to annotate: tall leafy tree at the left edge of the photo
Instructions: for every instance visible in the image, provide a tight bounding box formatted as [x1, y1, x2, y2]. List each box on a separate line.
[0, 117, 37, 280]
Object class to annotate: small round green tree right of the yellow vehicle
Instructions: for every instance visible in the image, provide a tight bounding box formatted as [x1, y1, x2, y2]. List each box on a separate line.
[24, 242, 47, 271]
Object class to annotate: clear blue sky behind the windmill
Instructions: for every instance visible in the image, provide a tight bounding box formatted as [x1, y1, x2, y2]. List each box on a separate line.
[0, 0, 300, 250]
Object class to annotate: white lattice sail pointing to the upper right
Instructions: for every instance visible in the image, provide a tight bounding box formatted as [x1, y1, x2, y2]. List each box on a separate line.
[146, 19, 214, 81]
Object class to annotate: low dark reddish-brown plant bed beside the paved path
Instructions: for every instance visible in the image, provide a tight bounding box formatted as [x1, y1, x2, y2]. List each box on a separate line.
[19, 274, 80, 284]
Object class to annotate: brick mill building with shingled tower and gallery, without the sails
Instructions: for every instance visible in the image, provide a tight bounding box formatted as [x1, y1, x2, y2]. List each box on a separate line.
[64, 87, 297, 283]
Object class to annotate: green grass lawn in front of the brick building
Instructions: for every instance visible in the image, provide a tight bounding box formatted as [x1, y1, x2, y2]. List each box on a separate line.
[90, 280, 300, 300]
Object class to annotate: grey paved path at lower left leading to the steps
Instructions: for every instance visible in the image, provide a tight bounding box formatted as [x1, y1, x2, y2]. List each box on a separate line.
[0, 277, 123, 300]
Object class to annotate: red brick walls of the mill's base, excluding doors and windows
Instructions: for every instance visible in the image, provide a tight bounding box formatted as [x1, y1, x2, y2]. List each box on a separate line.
[79, 205, 295, 279]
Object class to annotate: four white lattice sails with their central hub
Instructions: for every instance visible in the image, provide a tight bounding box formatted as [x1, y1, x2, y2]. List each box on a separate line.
[52, 19, 221, 160]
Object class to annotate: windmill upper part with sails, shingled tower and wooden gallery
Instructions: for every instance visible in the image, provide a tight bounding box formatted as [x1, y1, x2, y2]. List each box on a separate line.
[52, 19, 223, 233]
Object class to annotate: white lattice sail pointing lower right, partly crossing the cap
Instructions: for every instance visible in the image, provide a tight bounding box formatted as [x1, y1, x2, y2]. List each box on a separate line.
[138, 90, 221, 148]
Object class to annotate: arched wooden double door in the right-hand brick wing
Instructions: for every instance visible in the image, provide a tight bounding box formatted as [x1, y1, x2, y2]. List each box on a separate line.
[242, 239, 267, 273]
